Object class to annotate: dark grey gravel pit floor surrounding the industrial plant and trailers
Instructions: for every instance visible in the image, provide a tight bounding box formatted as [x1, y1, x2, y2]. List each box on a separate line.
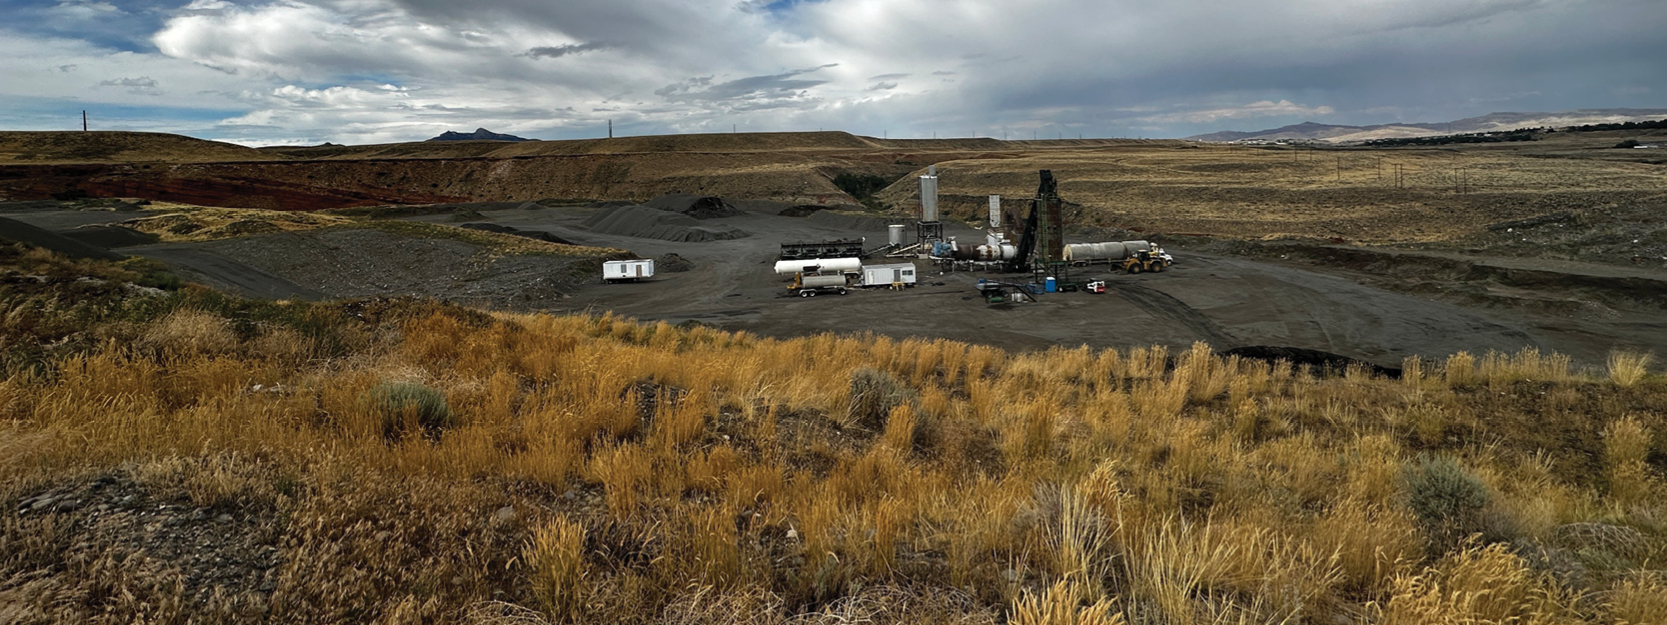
[5, 202, 1667, 367]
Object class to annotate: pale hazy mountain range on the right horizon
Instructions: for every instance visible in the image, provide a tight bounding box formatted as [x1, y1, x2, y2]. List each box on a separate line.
[1187, 108, 1667, 143]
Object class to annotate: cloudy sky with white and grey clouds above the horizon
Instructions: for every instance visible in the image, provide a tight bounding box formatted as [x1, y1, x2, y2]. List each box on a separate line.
[0, 0, 1667, 145]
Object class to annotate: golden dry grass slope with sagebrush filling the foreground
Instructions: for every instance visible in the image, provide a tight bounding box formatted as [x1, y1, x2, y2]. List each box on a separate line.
[0, 241, 1667, 623]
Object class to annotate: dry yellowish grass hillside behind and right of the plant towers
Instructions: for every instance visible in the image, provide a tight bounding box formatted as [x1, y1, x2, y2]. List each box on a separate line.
[880, 142, 1667, 243]
